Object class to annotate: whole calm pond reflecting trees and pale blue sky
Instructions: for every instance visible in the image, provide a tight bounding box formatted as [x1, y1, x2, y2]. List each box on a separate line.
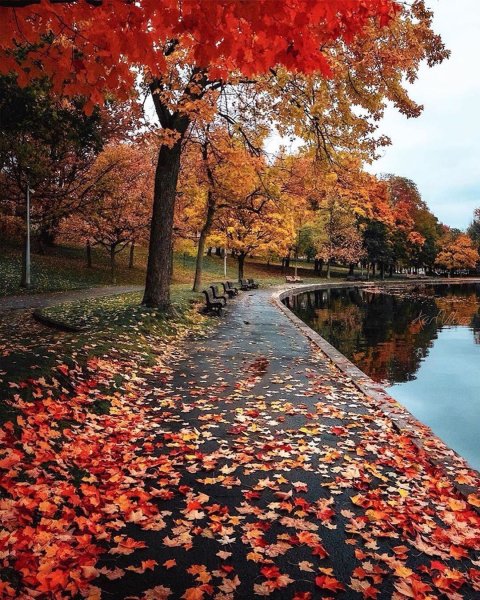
[285, 284, 480, 470]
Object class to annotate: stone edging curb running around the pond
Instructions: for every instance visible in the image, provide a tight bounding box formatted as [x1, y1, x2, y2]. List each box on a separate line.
[271, 279, 480, 514]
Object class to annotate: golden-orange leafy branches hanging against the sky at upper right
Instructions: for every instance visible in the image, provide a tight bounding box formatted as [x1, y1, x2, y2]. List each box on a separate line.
[260, 1, 449, 161]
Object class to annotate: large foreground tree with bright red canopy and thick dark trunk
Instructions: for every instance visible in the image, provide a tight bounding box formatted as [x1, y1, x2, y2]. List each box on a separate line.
[0, 0, 445, 308]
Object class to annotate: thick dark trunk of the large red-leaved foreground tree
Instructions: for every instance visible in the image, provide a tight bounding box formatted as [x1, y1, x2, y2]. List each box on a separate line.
[143, 132, 184, 310]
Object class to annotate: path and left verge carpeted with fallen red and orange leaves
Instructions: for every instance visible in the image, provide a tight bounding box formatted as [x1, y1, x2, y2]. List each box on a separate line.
[0, 291, 480, 600]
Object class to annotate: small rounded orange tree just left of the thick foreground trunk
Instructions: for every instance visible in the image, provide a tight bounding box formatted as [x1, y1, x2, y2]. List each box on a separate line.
[63, 144, 153, 283]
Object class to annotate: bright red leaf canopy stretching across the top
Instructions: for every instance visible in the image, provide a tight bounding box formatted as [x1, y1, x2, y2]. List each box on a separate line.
[0, 0, 398, 111]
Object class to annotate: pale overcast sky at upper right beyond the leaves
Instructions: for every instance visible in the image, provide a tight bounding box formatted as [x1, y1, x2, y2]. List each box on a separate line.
[370, 0, 480, 229]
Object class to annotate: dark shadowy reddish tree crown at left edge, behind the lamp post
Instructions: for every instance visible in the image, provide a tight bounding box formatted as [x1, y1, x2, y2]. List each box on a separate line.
[0, 76, 135, 250]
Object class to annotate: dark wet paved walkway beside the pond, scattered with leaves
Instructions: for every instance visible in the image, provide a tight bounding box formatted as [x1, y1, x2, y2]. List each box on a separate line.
[97, 290, 480, 600]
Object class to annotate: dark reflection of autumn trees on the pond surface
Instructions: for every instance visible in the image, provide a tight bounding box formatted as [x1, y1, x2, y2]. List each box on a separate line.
[291, 284, 480, 385]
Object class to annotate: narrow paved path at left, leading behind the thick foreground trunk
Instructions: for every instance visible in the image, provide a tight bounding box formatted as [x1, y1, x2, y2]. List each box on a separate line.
[0, 285, 143, 311]
